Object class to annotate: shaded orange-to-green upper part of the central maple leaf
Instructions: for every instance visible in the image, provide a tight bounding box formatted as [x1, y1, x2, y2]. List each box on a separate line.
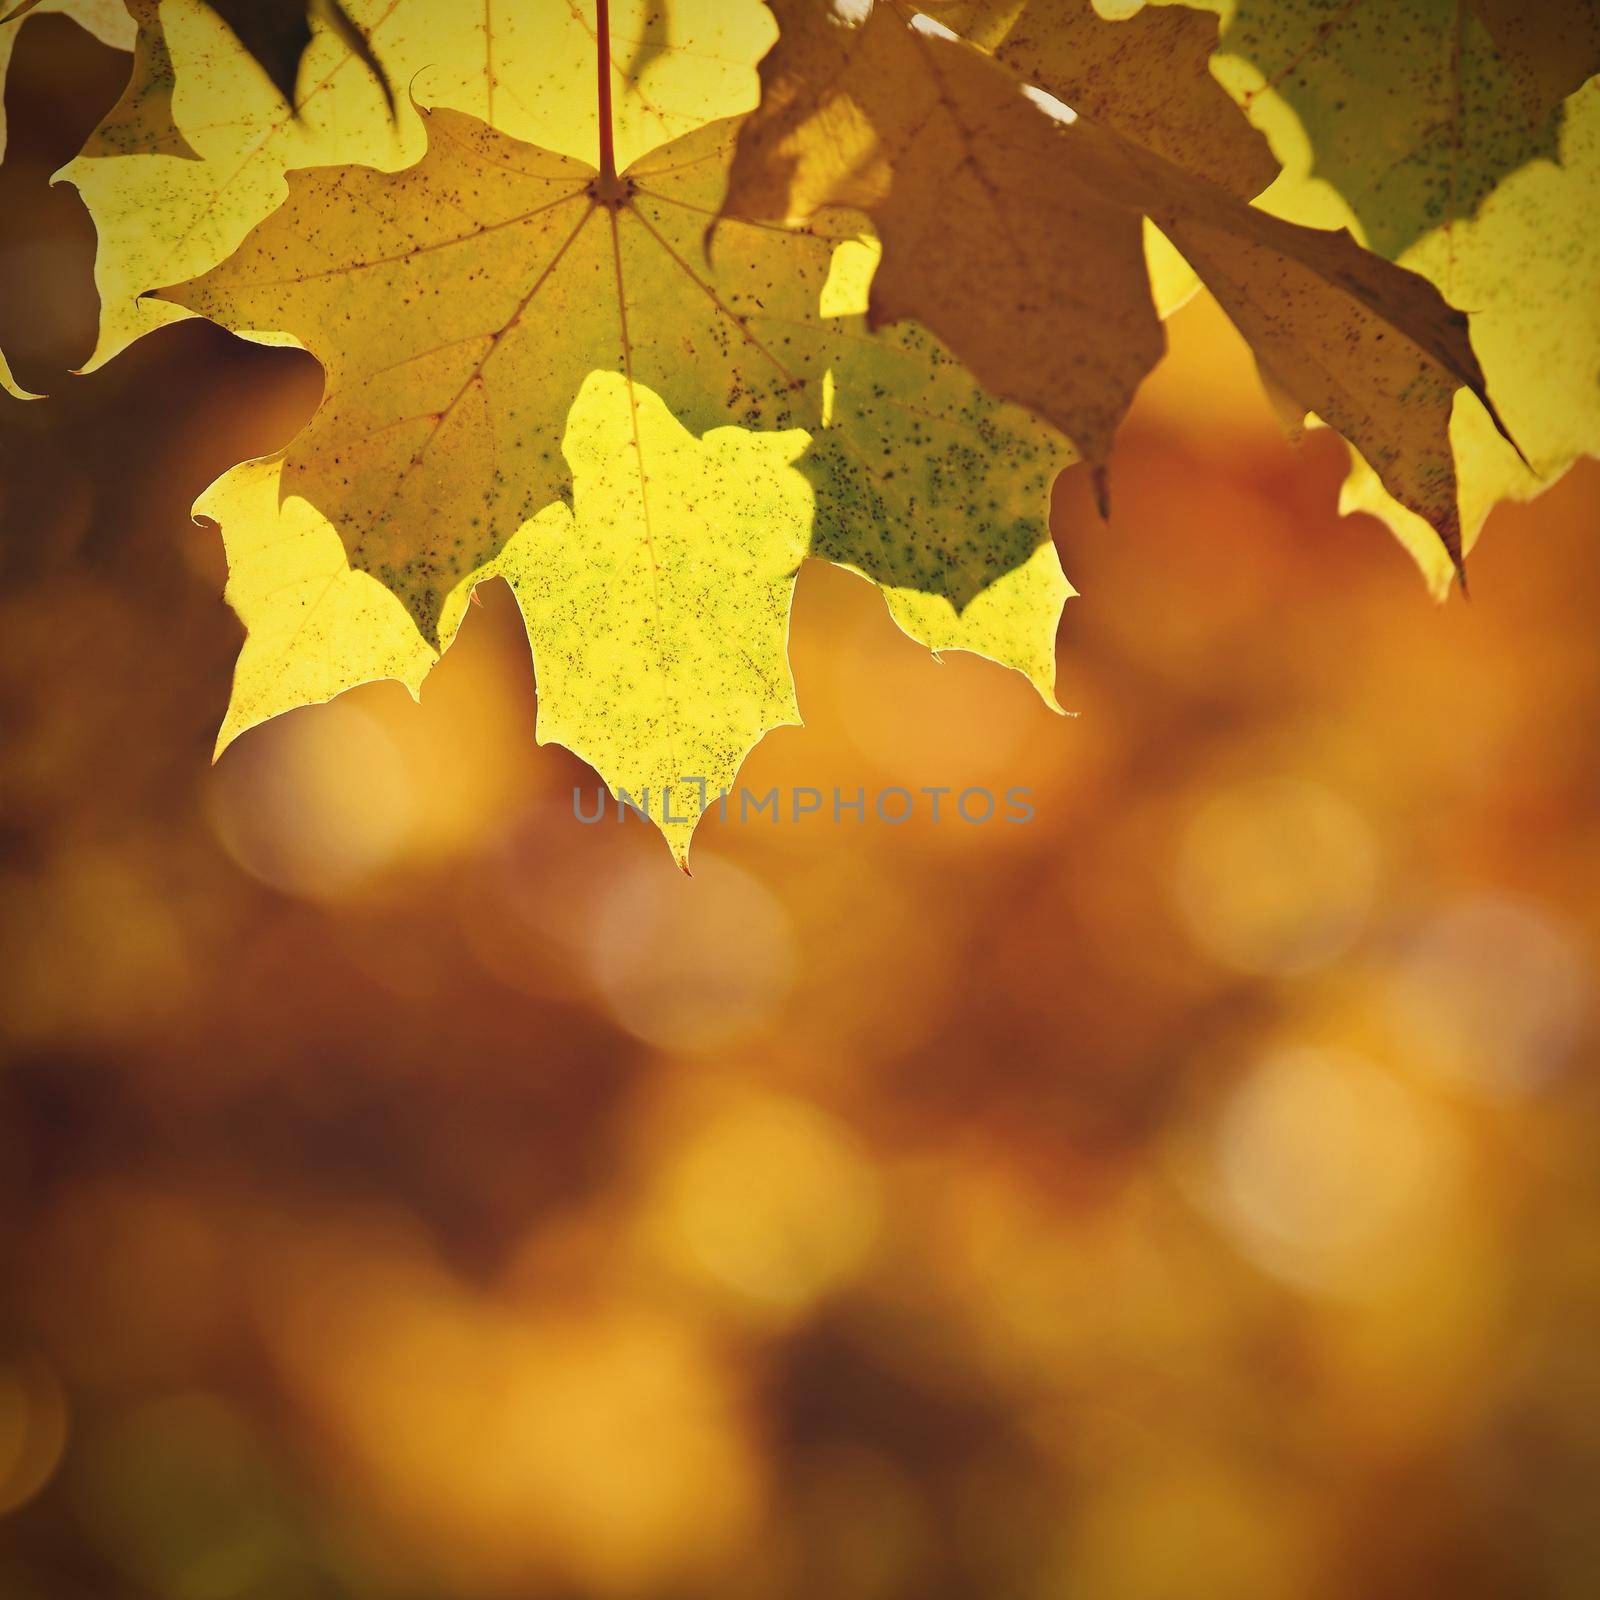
[158, 110, 1064, 624]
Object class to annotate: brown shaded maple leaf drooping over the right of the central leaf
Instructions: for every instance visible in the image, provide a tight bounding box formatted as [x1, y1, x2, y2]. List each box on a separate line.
[725, 0, 1510, 576]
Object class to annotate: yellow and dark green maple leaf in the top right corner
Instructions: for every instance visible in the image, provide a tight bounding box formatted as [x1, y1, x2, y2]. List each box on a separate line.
[1164, 0, 1600, 594]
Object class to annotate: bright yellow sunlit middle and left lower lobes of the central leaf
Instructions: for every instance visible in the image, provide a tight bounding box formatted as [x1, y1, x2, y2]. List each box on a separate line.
[195, 373, 813, 862]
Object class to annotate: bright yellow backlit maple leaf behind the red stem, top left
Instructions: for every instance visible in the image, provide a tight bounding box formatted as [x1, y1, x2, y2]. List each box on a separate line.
[58, 0, 773, 371]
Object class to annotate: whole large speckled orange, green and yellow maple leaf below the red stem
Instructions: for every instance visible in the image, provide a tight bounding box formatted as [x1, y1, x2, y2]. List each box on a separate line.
[162, 110, 1070, 851]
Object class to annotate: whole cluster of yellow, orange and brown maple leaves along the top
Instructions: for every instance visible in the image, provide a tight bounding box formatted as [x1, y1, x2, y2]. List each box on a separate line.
[0, 0, 1600, 861]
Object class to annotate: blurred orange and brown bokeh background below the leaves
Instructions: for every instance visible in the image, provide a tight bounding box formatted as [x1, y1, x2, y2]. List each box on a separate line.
[0, 16, 1600, 1600]
